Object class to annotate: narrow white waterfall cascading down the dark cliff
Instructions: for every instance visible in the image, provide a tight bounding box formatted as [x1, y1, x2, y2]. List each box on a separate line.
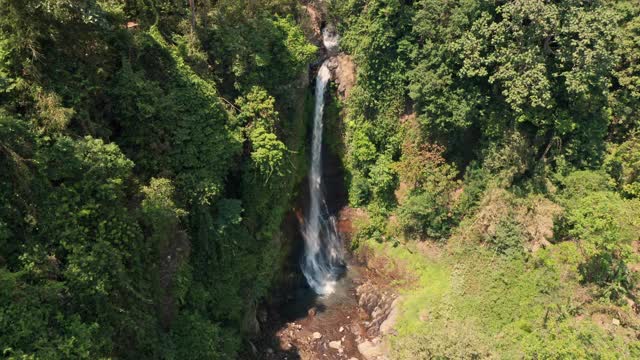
[302, 29, 344, 295]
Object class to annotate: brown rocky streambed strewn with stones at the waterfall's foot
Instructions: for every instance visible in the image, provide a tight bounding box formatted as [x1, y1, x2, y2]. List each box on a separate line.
[256, 210, 401, 360]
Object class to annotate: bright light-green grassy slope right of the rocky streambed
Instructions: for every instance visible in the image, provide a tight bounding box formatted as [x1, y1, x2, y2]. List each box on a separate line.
[368, 242, 640, 359]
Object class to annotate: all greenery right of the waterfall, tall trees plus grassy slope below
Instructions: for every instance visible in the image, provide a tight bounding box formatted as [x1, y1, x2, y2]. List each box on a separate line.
[332, 0, 640, 359]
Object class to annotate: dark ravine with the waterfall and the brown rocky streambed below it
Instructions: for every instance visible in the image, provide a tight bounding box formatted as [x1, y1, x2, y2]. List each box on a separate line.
[252, 21, 393, 360]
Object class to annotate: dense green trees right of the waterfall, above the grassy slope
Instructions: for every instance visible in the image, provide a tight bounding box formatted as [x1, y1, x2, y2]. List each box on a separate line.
[332, 0, 640, 243]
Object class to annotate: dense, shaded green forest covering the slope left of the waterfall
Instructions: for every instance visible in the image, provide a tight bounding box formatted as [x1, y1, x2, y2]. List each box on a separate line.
[0, 0, 316, 359]
